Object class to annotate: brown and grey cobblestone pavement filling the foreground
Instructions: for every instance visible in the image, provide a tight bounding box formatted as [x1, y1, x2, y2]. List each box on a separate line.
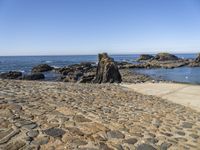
[0, 80, 200, 150]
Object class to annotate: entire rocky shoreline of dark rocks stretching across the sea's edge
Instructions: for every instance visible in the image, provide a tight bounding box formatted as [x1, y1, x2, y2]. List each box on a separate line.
[0, 53, 200, 83]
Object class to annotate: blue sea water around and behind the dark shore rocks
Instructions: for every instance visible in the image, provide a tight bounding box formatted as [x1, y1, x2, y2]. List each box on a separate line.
[0, 54, 200, 84]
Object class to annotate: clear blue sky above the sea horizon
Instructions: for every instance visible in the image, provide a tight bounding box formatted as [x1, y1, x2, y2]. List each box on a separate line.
[0, 0, 200, 55]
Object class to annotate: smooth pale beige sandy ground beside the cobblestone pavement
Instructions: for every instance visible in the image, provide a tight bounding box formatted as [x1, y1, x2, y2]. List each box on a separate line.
[122, 83, 200, 112]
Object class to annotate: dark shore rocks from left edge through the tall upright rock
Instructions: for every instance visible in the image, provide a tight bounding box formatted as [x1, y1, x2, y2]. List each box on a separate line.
[0, 53, 122, 83]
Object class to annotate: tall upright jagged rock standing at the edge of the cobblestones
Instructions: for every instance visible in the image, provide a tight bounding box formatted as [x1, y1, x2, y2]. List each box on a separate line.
[94, 53, 122, 83]
